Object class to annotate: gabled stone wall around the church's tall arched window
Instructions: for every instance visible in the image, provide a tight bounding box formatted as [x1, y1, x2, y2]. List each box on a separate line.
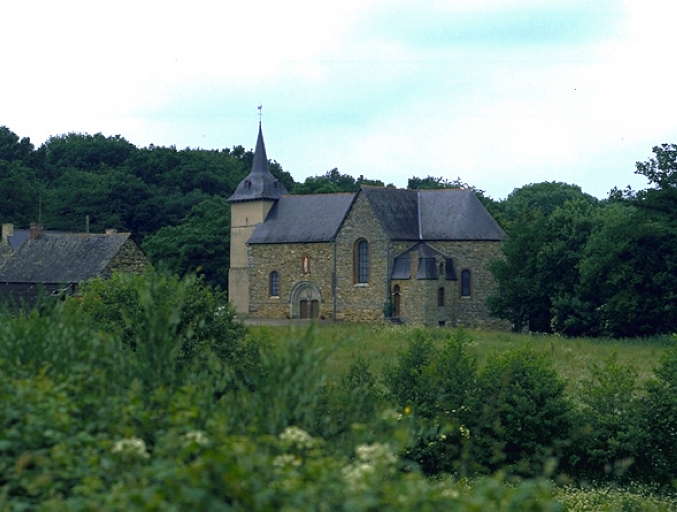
[336, 192, 393, 322]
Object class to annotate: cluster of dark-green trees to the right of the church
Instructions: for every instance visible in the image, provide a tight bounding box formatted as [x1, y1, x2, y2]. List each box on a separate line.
[490, 144, 677, 337]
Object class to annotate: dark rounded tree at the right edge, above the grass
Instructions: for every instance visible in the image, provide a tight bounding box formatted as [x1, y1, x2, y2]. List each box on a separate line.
[579, 204, 677, 336]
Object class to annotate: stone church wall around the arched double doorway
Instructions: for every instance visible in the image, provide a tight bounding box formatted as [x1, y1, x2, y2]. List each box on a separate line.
[249, 242, 334, 319]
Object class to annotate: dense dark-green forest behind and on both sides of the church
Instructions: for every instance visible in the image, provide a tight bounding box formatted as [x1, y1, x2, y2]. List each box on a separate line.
[0, 127, 677, 337]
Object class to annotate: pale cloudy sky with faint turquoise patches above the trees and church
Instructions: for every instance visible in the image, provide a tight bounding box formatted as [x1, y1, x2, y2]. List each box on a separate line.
[0, 0, 677, 199]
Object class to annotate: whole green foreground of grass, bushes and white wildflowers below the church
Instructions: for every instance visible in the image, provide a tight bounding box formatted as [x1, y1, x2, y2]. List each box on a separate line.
[0, 275, 677, 512]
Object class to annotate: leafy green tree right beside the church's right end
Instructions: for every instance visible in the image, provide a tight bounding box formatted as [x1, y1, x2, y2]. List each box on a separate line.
[488, 182, 599, 334]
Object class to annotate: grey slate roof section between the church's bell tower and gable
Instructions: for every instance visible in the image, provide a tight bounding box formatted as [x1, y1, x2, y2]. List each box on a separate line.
[248, 194, 355, 244]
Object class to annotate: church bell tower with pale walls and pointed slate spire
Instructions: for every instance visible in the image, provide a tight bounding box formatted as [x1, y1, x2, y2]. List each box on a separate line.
[228, 121, 287, 317]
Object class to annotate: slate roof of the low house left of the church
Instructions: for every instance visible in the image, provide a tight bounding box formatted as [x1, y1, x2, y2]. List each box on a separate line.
[0, 233, 129, 284]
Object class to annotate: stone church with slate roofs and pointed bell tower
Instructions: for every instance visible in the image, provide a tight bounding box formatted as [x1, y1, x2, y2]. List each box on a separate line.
[228, 124, 506, 328]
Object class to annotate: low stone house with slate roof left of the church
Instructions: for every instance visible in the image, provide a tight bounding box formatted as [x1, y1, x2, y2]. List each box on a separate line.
[0, 223, 148, 305]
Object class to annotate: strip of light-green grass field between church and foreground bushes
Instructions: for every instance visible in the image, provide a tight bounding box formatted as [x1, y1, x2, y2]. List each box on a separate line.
[250, 323, 674, 385]
